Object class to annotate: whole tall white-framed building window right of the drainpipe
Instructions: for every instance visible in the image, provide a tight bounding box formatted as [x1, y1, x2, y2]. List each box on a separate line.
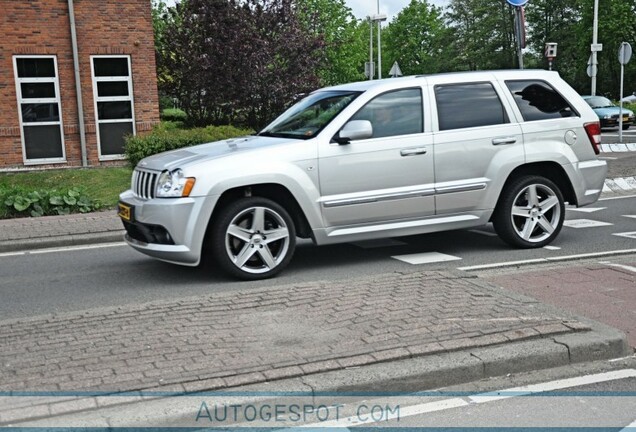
[91, 56, 135, 160]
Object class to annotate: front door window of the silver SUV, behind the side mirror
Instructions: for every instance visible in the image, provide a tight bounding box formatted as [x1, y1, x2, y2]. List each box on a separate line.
[351, 89, 423, 138]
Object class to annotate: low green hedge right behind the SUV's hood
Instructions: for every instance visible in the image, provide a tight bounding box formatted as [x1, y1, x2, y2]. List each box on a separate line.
[125, 122, 252, 167]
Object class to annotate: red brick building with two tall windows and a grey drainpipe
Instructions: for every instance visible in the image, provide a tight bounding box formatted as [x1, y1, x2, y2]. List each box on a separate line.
[0, 0, 159, 170]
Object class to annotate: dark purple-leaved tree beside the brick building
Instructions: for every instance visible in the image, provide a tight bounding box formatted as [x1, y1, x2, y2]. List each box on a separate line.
[158, 0, 322, 129]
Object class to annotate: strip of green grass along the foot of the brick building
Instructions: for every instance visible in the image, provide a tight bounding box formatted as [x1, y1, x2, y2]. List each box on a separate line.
[0, 167, 132, 209]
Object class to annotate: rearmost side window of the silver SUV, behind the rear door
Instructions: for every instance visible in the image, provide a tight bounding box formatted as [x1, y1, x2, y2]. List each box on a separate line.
[506, 80, 574, 121]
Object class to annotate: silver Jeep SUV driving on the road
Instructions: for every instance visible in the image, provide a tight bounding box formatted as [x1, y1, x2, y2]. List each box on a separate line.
[119, 70, 607, 279]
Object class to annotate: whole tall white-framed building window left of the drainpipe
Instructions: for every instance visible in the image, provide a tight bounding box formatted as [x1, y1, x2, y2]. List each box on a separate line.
[13, 56, 66, 164]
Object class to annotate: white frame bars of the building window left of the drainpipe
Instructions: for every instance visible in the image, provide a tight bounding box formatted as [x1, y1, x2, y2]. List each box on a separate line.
[13, 55, 66, 165]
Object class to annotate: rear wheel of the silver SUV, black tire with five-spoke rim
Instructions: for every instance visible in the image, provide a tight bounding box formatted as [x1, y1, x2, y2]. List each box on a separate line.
[492, 176, 565, 248]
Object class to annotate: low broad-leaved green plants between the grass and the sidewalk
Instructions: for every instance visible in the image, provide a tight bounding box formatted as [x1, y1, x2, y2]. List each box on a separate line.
[0, 185, 101, 219]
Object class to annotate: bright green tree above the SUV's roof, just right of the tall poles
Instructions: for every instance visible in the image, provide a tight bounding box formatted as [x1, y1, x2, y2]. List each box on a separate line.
[382, 0, 449, 76]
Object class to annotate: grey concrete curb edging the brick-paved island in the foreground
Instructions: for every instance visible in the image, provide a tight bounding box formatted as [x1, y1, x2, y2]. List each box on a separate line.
[0, 320, 631, 427]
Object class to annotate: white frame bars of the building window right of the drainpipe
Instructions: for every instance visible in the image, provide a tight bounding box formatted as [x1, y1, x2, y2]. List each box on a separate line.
[91, 55, 137, 161]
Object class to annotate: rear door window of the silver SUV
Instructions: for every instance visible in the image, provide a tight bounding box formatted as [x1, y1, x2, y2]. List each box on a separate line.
[435, 83, 508, 130]
